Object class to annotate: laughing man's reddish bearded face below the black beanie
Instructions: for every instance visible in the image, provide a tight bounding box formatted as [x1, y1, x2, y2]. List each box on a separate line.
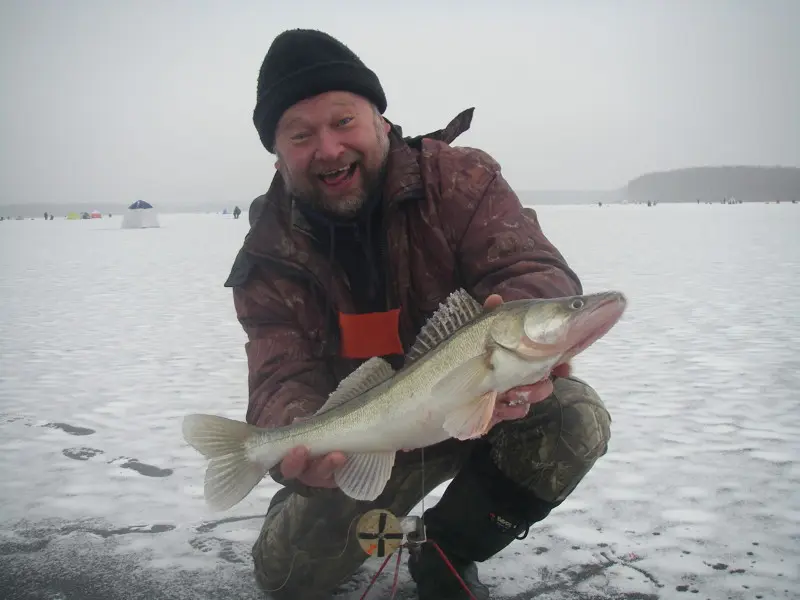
[275, 92, 390, 217]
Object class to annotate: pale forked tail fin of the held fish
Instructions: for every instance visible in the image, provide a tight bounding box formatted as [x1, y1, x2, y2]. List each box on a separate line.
[183, 415, 280, 510]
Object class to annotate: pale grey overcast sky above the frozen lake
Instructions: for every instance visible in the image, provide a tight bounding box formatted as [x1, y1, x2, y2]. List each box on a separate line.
[0, 0, 800, 206]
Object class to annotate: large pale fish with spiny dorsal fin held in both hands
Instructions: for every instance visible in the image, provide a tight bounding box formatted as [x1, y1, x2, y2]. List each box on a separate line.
[182, 289, 627, 511]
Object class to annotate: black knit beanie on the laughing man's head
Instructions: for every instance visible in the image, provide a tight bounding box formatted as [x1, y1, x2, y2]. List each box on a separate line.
[253, 29, 386, 152]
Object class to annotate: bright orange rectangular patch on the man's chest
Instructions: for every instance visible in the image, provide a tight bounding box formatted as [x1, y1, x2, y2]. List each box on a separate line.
[339, 308, 403, 358]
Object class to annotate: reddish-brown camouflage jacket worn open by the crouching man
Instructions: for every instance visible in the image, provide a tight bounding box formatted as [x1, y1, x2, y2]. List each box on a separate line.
[225, 109, 581, 427]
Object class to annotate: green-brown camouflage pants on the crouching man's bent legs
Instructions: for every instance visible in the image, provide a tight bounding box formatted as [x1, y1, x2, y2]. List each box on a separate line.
[253, 377, 611, 600]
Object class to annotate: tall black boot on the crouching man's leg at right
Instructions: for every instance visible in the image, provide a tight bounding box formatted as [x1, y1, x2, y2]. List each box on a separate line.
[408, 445, 555, 600]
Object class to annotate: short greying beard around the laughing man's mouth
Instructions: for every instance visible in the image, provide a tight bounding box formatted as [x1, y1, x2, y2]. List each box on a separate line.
[279, 118, 389, 220]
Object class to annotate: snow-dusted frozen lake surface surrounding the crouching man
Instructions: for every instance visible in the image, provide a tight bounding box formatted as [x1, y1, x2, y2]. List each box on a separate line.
[0, 204, 800, 600]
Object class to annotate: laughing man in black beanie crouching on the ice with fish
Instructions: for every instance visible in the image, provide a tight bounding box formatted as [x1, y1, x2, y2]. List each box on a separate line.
[226, 30, 610, 600]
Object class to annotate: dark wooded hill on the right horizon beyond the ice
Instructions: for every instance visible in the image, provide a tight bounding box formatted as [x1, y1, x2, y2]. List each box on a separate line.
[626, 167, 800, 202]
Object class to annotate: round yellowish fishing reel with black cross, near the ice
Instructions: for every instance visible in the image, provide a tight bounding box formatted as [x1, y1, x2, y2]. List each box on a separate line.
[356, 508, 427, 557]
